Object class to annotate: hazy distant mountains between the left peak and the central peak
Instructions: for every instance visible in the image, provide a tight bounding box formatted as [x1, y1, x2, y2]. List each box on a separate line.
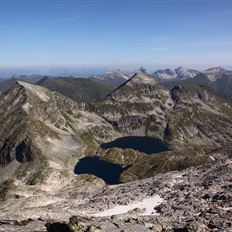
[0, 71, 130, 103]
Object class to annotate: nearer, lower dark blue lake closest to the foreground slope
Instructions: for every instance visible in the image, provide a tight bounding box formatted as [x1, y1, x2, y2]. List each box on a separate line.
[74, 157, 123, 184]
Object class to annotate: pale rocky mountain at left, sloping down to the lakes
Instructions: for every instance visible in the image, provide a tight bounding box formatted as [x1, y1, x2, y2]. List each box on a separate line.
[0, 82, 117, 183]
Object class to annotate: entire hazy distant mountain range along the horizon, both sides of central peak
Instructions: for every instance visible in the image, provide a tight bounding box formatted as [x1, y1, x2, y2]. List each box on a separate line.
[0, 67, 232, 103]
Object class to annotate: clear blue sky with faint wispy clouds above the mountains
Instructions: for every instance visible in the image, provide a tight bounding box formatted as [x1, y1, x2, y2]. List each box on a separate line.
[0, 0, 232, 68]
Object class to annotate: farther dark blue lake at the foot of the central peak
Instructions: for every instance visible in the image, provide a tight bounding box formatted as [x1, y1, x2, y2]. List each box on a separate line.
[101, 136, 169, 154]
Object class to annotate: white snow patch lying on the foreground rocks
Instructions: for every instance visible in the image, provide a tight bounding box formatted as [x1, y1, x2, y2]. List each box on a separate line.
[93, 195, 163, 217]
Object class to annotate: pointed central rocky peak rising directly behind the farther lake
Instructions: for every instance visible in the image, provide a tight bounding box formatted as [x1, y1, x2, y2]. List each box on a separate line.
[95, 73, 174, 138]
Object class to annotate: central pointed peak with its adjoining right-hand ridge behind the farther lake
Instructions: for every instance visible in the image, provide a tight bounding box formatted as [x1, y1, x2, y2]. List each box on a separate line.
[94, 73, 232, 149]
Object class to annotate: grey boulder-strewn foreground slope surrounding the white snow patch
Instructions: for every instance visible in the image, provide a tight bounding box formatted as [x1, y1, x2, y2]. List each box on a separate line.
[0, 140, 232, 232]
